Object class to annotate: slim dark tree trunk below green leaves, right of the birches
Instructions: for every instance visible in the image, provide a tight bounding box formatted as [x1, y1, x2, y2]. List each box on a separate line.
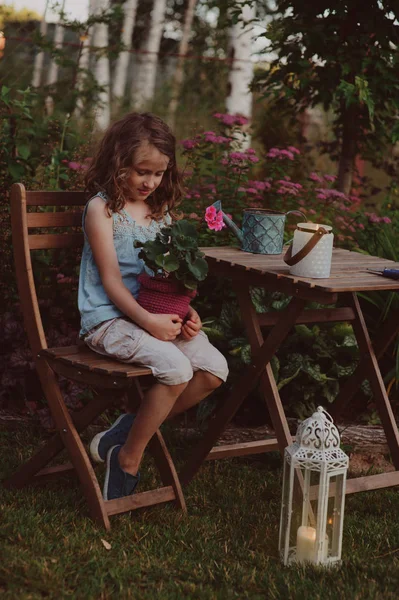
[337, 106, 358, 194]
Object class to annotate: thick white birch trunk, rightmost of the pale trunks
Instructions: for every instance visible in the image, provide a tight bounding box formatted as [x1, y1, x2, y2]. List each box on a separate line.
[226, 4, 256, 149]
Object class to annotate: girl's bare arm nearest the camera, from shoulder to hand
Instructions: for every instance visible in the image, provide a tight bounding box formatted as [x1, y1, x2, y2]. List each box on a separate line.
[85, 198, 182, 341]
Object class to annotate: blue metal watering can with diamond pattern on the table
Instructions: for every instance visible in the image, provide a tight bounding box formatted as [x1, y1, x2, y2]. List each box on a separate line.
[212, 200, 307, 254]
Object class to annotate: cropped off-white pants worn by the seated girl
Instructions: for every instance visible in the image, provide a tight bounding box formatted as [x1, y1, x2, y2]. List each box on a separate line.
[85, 317, 229, 385]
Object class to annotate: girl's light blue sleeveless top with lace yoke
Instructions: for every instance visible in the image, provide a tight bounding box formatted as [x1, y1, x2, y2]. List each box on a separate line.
[78, 192, 171, 336]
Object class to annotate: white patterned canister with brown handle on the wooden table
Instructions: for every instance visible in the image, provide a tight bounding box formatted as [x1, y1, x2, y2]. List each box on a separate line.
[290, 223, 334, 278]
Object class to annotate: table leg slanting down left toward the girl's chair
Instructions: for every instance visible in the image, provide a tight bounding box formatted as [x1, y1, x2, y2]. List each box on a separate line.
[179, 292, 306, 484]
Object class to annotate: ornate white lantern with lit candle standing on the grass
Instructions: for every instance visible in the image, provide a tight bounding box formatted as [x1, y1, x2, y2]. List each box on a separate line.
[279, 406, 349, 565]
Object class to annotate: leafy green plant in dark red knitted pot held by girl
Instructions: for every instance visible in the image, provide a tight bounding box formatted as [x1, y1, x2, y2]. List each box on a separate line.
[135, 220, 208, 319]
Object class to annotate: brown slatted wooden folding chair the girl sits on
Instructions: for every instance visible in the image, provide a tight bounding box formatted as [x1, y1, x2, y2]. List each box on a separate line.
[4, 183, 186, 529]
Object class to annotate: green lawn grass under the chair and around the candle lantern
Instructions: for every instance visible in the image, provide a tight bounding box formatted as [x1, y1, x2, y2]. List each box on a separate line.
[0, 429, 399, 600]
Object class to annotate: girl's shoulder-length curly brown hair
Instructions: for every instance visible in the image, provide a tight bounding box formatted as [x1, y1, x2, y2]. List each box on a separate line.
[85, 113, 183, 219]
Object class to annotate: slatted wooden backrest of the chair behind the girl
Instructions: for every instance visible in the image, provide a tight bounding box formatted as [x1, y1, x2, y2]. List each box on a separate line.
[11, 183, 86, 359]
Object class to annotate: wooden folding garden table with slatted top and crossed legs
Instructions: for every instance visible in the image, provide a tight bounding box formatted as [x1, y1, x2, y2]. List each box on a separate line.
[180, 247, 399, 493]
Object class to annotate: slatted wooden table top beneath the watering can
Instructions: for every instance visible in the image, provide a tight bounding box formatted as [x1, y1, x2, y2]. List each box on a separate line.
[201, 246, 399, 294]
